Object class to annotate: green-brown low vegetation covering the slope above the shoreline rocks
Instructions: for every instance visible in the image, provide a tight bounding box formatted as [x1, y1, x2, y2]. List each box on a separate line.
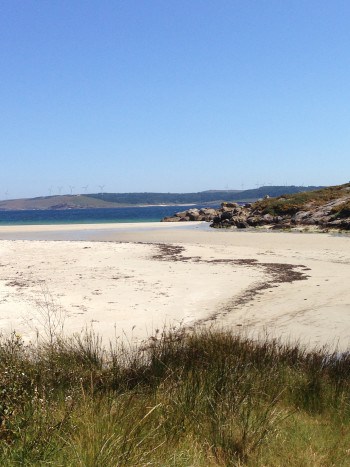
[253, 183, 350, 217]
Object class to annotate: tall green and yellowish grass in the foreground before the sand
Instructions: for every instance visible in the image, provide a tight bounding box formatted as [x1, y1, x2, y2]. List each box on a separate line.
[0, 330, 350, 467]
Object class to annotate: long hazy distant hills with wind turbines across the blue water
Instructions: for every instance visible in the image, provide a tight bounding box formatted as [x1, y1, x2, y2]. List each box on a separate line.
[0, 186, 321, 210]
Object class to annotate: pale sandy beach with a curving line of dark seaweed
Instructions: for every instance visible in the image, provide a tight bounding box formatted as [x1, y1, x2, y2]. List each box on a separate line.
[0, 223, 350, 350]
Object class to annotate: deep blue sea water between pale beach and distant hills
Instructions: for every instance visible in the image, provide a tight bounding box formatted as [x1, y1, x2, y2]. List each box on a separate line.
[0, 205, 216, 225]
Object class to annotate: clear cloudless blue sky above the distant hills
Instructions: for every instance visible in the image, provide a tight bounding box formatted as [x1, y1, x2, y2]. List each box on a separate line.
[0, 0, 350, 199]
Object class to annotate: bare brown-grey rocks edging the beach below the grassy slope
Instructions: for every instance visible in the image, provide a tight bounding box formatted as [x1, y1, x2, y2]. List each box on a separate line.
[163, 197, 350, 230]
